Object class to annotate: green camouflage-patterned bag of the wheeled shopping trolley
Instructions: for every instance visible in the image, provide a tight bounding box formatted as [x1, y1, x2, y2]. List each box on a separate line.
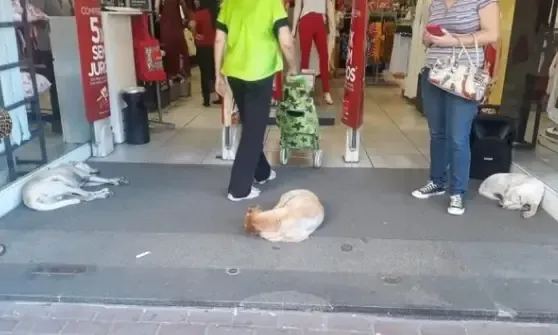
[276, 76, 320, 150]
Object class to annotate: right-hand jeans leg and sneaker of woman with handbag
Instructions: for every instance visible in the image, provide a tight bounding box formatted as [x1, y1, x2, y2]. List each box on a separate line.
[444, 92, 478, 215]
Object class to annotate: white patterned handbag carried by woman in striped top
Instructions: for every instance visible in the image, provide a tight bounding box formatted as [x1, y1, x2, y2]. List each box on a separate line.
[428, 36, 490, 101]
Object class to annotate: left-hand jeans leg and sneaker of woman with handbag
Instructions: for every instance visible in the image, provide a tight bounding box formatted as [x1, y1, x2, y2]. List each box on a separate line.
[412, 69, 448, 199]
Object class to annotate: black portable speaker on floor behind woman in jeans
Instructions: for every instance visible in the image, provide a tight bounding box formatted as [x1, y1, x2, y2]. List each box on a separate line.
[470, 107, 515, 180]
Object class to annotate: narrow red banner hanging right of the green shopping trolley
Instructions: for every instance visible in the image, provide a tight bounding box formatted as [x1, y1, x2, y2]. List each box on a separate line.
[341, 0, 368, 128]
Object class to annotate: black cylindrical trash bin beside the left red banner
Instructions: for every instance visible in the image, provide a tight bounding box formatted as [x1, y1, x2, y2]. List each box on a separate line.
[122, 86, 150, 145]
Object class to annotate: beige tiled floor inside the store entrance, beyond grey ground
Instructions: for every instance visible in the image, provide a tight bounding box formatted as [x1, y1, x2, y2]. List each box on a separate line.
[94, 74, 429, 168]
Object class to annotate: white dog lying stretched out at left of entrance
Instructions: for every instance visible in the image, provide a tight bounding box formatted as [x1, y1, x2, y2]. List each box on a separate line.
[23, 163, 128, 211]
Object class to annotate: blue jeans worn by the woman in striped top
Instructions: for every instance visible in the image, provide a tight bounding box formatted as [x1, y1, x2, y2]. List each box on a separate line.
[421, 69, 478, 195]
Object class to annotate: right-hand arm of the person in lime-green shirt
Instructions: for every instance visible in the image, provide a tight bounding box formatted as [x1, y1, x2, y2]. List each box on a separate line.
[271, 0, 296, 74]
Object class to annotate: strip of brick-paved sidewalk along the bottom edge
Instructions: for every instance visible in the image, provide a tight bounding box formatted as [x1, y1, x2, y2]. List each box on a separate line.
[0, 302, 558, 335]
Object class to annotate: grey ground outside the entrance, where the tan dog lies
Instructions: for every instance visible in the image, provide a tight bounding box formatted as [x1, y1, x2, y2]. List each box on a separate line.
[0, 163, 558, 318]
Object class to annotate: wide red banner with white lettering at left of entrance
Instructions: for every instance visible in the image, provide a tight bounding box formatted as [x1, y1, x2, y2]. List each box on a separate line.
[74, 0, 110, 122]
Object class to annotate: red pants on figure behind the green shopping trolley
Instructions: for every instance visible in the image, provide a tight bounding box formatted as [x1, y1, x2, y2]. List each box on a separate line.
[298, 13, 329, 93]
